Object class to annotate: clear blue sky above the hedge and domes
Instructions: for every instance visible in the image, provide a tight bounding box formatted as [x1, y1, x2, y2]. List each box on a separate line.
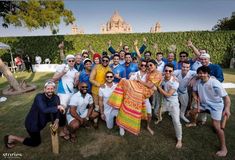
[0, 0, 235, 37]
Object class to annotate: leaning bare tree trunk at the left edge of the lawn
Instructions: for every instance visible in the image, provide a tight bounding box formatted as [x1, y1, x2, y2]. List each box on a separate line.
[0, 58, 21, 91]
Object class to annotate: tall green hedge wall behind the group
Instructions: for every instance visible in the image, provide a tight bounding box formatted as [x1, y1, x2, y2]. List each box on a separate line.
[0, 31, 235, 67]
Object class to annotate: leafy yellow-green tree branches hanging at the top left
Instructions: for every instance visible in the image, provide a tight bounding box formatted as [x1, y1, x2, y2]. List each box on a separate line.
[0, 0, 75, 34]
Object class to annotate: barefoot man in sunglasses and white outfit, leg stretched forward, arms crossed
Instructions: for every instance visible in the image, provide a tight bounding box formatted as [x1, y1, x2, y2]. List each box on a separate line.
[157, 63, 182, 148]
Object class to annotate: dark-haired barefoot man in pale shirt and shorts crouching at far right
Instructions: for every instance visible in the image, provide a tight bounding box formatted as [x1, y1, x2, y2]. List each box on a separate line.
[187, 66, 231, 157]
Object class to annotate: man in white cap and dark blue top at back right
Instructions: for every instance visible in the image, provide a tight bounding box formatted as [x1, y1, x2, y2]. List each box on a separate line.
[200, 53, 224, 82]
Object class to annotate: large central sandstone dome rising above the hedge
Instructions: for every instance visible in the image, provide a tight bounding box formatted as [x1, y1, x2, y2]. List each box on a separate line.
[100, 11, 132, 34]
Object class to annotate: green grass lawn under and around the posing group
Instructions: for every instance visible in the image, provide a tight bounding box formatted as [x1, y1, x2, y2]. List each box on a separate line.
[0, 69, 235, 160]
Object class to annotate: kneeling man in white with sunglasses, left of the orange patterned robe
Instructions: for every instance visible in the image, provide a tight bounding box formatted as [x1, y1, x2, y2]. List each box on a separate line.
[99, 71, 118, 129]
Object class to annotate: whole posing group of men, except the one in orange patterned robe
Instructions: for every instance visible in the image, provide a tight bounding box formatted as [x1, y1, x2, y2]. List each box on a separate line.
[4, 41, 231, 156]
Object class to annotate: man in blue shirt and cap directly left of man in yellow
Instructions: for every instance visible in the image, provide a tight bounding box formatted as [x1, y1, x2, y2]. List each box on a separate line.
[79, 58, 92, 94]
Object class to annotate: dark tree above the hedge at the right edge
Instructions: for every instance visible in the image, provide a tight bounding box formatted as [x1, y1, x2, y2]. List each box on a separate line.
[212, 15, 235, 31]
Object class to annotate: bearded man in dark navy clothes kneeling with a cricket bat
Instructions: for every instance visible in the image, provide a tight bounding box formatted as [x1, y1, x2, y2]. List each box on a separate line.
[4, 81, 66, 149]
